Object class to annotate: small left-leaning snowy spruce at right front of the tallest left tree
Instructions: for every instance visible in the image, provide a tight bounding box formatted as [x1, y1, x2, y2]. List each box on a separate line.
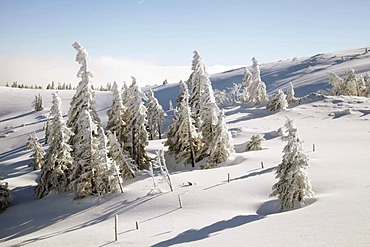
[107, 131, 137, 180]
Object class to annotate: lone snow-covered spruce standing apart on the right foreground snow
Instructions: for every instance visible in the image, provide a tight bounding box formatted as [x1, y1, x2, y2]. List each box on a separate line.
[271, 118, 313, 210]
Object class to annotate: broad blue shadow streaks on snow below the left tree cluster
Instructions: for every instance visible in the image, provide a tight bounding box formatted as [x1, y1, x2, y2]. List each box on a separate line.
[0, 191, 168, 246]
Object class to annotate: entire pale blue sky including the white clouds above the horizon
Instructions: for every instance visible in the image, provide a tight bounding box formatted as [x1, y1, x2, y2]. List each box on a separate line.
[0, 0, 370, 85]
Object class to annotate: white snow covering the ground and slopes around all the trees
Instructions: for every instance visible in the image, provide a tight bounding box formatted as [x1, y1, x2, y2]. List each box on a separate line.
[0, 49, 370, 246]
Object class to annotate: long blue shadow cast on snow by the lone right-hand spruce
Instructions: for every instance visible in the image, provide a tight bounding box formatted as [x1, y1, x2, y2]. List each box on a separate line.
[152, 215, 265, 247]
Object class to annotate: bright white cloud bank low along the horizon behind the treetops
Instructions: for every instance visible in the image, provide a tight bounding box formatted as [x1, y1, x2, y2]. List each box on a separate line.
[0, 54, 244, 86]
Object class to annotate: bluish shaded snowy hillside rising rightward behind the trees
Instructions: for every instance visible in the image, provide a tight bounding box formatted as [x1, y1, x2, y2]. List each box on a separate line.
[153, 48, 370, 110]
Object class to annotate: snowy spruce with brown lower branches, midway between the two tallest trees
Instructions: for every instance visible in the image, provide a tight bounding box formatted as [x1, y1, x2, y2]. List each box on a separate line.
[123, 77, 150, 170]
